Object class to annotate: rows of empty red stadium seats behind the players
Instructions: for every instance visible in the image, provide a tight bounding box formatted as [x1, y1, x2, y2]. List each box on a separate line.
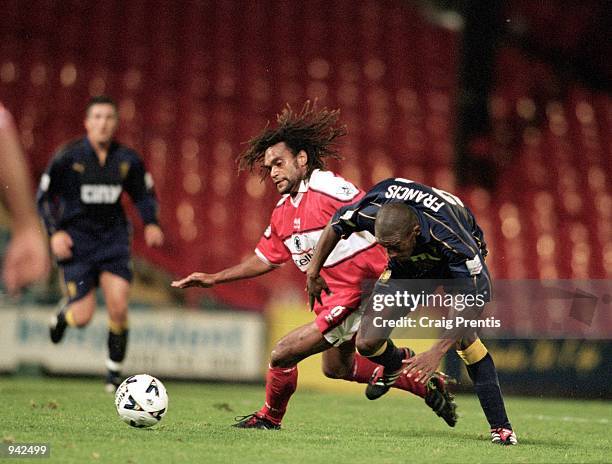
[0, 0, 612, 314]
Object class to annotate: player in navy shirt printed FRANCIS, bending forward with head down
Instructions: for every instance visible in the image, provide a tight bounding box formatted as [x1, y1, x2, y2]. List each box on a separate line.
[307, 178, 517, 445]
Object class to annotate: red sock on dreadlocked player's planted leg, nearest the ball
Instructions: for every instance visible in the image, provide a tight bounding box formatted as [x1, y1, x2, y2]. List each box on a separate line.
[257, 366, 297, 424]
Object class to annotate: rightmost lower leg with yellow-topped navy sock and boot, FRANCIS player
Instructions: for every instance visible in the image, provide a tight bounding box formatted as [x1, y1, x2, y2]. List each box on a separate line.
[455, 332, 518, 445]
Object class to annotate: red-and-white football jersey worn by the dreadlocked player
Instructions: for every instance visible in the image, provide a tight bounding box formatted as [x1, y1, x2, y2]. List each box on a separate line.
[255, 169, 387, 314]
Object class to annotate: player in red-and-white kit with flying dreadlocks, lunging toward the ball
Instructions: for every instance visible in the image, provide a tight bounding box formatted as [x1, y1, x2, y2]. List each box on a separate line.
[172, 103, 457, 429]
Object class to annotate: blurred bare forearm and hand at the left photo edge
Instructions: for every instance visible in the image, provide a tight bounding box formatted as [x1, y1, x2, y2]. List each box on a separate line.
[0, 103, 50, 295]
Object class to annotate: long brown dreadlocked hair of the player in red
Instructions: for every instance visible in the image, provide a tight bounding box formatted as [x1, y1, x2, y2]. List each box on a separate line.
[237, 101, 347, 177]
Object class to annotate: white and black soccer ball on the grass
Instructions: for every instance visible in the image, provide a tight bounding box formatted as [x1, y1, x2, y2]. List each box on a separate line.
[115, 374, 168, 428]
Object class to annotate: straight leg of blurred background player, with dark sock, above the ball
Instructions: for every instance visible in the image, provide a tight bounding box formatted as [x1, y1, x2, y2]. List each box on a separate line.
[100, 272, 130, 392]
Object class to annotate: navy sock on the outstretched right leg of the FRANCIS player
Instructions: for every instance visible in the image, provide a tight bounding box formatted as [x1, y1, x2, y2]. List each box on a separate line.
[466, 353, 512, 429]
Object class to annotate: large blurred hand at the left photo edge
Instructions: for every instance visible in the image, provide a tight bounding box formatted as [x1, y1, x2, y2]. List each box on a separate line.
[2, 227, 50, 295]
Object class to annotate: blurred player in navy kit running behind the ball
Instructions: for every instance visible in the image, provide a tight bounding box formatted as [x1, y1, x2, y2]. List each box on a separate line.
[38, 96, 164, 391]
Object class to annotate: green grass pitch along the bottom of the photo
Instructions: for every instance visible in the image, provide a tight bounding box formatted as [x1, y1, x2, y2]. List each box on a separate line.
[0, 377, 612, 464]
